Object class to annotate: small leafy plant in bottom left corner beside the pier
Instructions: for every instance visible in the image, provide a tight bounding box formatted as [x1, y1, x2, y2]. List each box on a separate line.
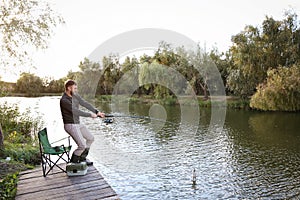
[0, 172, 19, 200]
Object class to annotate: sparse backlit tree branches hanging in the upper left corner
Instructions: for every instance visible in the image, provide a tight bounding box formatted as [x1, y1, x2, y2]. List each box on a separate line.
[0, 0, 64, 66]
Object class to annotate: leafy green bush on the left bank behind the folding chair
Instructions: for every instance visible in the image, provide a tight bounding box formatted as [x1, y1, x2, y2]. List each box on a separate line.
[0, 103, 42, 165]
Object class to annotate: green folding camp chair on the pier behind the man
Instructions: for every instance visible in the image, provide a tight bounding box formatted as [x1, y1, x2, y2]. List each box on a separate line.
[38, 128, 72, 177]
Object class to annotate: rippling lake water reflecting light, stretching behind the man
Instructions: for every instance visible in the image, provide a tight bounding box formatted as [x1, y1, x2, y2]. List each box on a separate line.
[0, 97, 300, 200]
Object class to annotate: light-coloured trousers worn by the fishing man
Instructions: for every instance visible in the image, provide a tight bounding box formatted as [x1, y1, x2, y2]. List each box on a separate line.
[64, 124, 94, 156]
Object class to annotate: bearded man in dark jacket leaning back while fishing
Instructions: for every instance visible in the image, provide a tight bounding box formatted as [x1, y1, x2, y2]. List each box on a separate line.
[60, 80, 105, 165]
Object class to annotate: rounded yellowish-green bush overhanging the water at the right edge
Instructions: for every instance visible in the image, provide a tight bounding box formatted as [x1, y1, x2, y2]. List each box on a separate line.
[250, 65, 300, 111]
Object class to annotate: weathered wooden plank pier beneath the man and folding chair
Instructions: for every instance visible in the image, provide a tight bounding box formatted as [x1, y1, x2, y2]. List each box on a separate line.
[16, 165, 119, 200]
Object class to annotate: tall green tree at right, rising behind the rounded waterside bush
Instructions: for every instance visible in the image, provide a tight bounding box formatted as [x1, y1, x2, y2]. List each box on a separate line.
[227, 12, 300, 98]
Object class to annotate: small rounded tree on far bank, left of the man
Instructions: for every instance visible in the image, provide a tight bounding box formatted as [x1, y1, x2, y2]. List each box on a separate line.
[16, 72, 43, 96]
